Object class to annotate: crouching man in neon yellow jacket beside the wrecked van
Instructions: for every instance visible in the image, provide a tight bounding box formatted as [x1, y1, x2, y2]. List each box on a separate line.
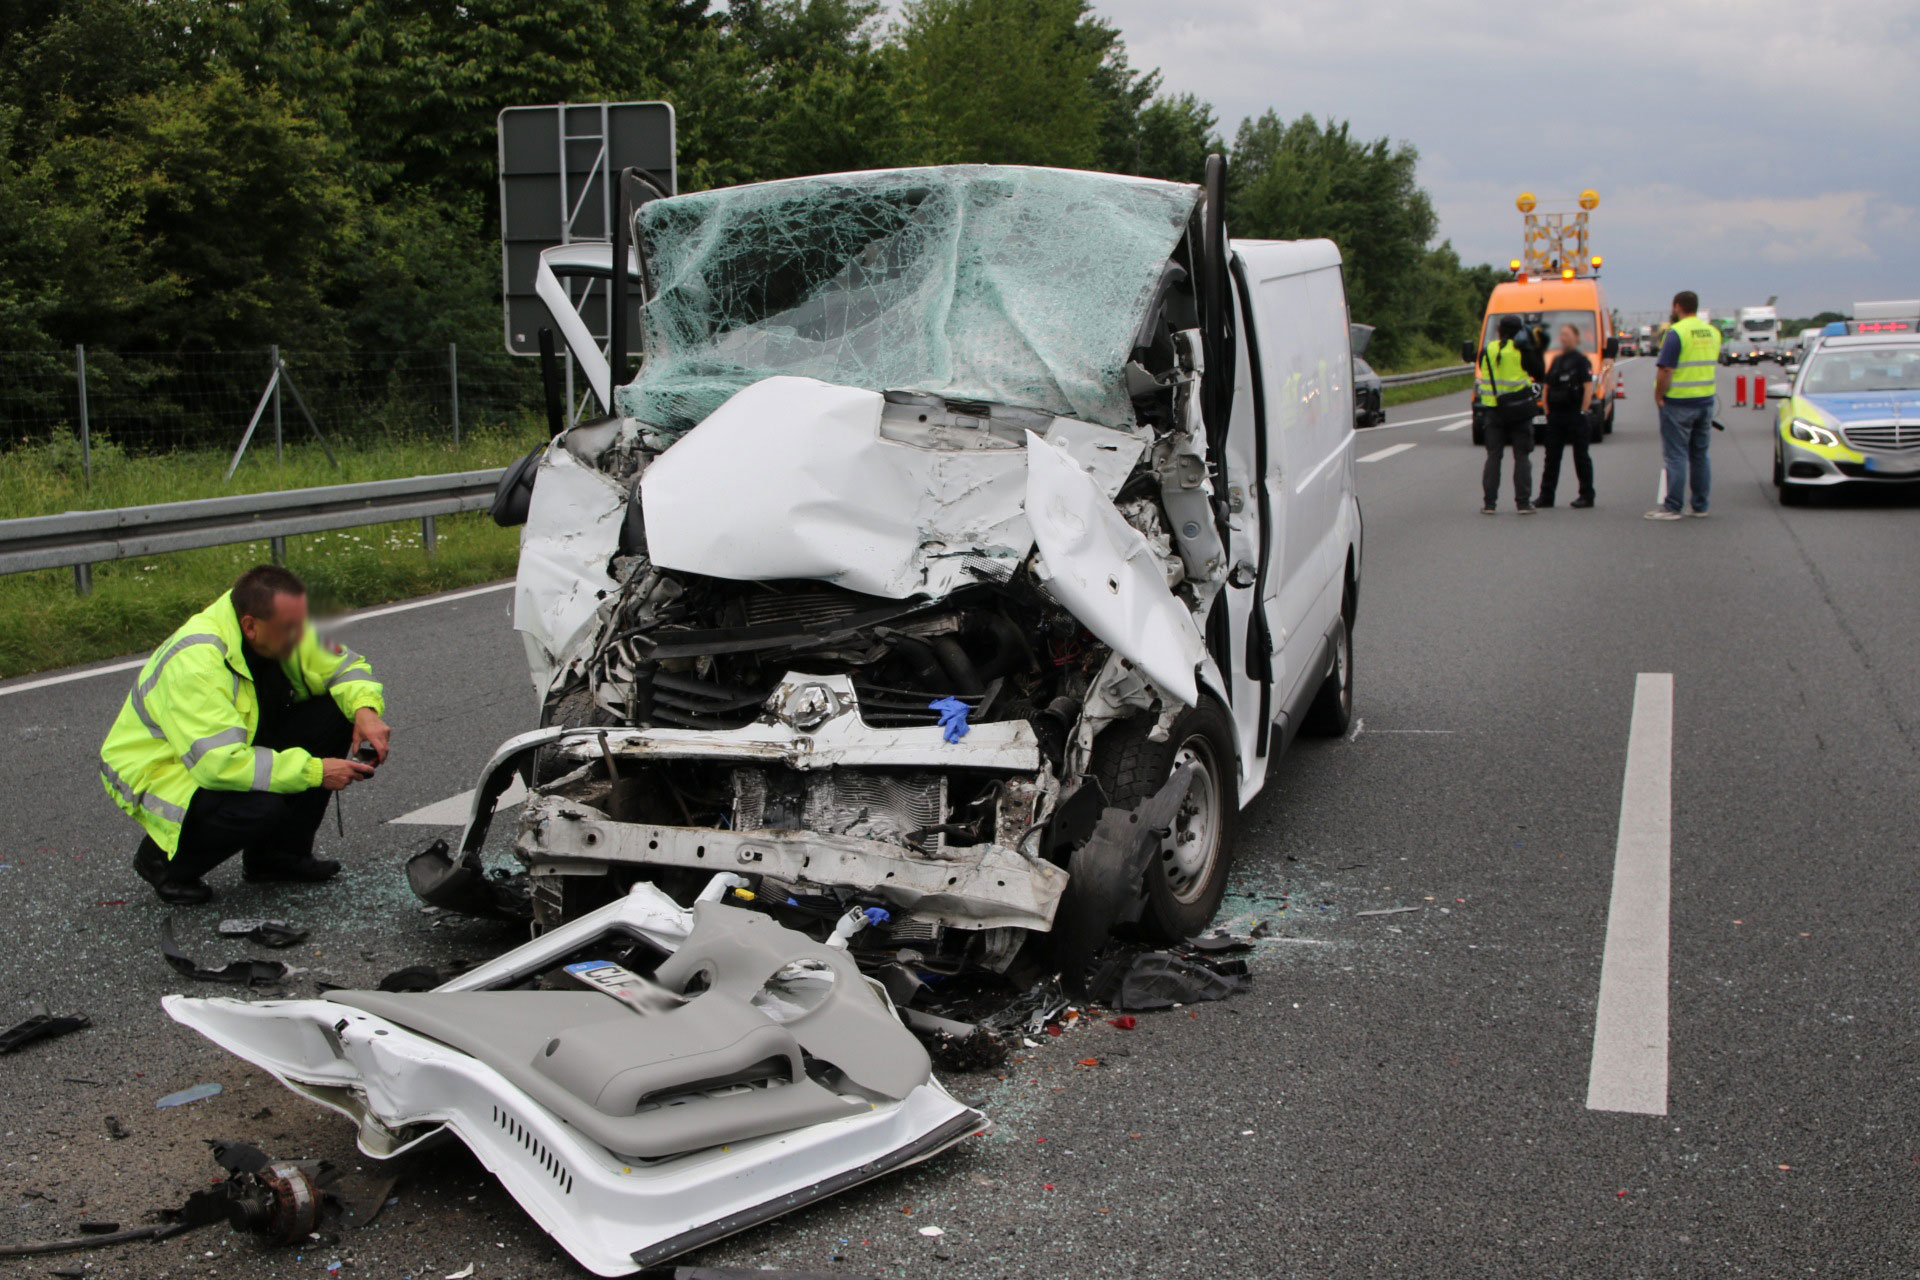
[100, 564, 388, 904]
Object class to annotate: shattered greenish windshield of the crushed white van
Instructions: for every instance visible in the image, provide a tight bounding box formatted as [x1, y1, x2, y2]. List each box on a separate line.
[618, 165, 1200, 439]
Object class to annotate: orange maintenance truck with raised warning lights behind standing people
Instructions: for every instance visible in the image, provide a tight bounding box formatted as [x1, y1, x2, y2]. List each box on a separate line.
[1461, 190, 1620, 445]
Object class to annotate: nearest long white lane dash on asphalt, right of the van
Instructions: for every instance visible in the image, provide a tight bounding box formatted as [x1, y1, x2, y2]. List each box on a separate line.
[1586, 672, 1674, 1115]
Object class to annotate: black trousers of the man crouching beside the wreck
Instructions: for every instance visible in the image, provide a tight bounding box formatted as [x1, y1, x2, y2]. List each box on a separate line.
[140, 695, 353, 881]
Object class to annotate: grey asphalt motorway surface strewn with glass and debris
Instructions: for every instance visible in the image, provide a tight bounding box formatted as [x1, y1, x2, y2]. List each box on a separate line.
[0, 361, 1920, 1280]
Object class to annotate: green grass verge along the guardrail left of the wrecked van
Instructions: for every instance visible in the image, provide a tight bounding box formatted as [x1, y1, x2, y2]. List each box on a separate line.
[0, 428, 538, 677]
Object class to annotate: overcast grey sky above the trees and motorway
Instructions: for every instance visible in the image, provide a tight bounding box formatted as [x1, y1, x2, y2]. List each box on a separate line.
[1094, 0, 1920, 317]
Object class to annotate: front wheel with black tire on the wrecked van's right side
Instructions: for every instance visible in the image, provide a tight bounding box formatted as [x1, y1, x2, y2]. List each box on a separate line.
[1089, 695, 1240, 942]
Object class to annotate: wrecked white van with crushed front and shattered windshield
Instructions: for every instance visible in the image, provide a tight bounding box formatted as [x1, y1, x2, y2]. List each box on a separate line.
[409, 163, 1361, 975]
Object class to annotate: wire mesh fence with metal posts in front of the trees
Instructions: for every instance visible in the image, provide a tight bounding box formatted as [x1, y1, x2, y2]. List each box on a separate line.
[0, 345, 543, 455]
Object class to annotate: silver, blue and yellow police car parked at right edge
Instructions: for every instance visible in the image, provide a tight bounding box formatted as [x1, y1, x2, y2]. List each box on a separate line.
[1768, 334, 1920, 507]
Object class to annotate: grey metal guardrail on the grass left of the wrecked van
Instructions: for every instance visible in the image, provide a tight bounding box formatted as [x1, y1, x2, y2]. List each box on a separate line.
[0, 466, 505, 595]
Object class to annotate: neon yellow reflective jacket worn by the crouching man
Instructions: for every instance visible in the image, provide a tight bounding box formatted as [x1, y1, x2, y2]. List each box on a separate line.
[100, 591, 386, 858]
